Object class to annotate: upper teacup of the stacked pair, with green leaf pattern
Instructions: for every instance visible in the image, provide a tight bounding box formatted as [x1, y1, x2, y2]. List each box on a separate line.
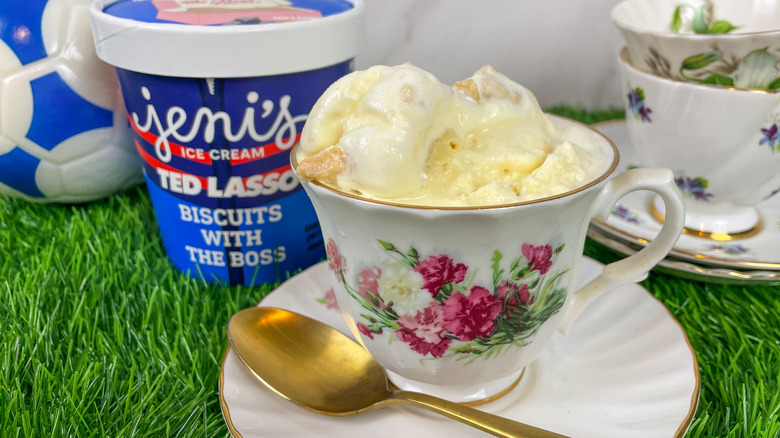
[611, 0, 780, 90]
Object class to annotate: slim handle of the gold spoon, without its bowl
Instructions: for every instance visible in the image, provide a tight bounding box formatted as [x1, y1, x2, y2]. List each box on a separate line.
[387, 391, 566, 438]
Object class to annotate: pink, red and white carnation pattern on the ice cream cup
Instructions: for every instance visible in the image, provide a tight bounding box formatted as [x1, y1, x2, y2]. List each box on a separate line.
[326, 239, 568, 363]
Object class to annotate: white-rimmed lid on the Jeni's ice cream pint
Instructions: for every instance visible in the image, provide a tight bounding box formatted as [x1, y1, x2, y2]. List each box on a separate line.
[90, 0, 365, 78]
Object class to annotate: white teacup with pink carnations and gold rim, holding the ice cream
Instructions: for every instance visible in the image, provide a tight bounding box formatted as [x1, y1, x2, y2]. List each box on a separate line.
[292, 114, 684, 402]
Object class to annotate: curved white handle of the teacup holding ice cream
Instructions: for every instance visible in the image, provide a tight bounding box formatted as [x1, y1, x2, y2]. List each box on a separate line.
[558, 168, 685, 334]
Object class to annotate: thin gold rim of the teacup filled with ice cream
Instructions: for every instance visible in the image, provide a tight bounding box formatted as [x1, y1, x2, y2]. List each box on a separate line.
[290, 114, 620, 211]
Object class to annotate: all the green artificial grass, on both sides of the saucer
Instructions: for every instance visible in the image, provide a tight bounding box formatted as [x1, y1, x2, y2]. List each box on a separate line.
[0, 107, 780, 438]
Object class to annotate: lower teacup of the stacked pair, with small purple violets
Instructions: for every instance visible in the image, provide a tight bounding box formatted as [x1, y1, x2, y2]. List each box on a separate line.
[620, 49, 780, 240]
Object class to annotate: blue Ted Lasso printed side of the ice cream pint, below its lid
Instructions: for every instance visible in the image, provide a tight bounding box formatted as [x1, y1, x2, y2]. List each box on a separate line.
[118, 61, 351, 286]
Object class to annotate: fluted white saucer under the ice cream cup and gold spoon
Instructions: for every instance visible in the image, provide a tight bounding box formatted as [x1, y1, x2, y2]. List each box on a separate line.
[219, 258, 699, 438]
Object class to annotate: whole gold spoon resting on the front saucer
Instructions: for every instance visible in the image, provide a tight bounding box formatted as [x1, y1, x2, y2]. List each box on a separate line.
[227, 307, 563, 438]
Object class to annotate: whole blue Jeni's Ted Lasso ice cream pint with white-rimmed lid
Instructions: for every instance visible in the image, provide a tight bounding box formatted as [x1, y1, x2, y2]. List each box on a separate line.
[90, 0, 365, 286]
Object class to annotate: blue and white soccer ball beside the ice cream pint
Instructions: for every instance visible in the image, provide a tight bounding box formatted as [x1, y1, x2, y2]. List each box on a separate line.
[0, 0, 143, 203]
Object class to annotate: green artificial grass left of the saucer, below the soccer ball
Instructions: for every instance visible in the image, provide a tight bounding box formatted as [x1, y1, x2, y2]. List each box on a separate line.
[0, 188, 268, 437]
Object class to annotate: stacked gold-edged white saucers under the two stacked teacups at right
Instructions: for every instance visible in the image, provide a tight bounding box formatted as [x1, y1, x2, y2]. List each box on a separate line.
[591, 121, 780, 274]
